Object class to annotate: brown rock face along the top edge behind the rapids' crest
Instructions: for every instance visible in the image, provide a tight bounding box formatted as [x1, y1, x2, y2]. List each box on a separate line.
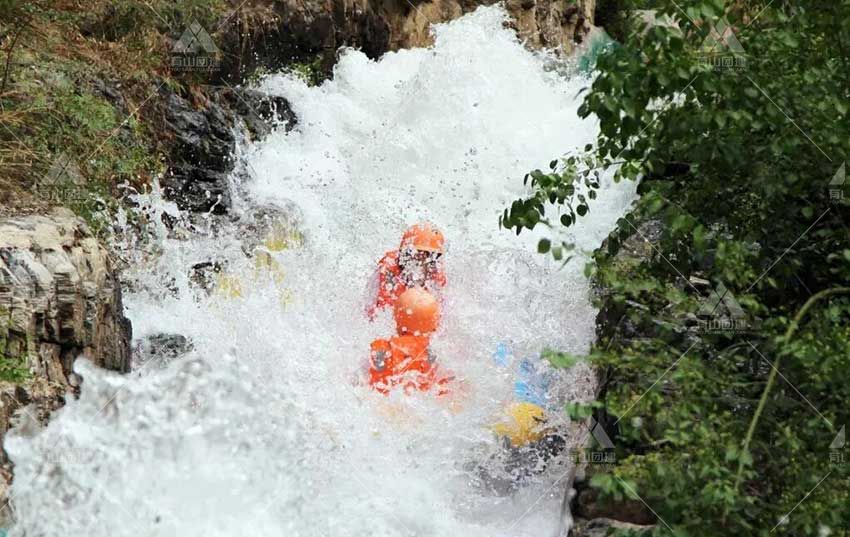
[215, 0, 596, 81]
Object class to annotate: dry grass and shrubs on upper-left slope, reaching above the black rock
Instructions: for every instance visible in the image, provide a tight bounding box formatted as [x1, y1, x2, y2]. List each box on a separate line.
[0, 0, 318, 220]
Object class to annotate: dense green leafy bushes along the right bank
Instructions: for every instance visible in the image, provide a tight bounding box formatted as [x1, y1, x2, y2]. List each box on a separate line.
[502, 0, 850, 536]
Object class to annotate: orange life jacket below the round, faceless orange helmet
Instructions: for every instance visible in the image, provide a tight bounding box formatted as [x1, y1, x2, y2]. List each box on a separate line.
[369, 336, 452, 395]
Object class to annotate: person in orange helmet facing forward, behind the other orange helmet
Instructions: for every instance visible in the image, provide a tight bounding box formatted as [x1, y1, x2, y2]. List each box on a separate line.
[366, 223, 446, 320]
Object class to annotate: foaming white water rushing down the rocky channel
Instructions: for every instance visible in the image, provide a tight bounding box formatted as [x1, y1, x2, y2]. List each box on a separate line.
[6, 8, 633, 537]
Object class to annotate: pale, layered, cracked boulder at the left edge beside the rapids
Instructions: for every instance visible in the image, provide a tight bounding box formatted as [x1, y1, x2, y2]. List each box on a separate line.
[0, 209, 132, 510]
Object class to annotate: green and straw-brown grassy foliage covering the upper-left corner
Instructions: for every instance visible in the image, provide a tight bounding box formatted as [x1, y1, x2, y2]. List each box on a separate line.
[0, 0, 228, 224]
